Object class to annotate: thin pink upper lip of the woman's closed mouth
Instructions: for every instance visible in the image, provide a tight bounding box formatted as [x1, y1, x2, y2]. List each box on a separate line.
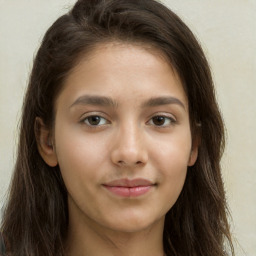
[103, 178, 154, 188]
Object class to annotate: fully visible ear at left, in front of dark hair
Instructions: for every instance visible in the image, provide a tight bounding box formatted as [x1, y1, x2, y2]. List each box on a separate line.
[34, 117, 58, 167]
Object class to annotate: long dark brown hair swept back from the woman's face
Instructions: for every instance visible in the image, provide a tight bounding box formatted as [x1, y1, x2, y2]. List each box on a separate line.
[2, 0, 234, 256]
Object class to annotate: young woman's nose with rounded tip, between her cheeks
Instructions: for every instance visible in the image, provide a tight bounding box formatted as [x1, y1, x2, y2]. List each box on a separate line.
[111, 125, 148, 167]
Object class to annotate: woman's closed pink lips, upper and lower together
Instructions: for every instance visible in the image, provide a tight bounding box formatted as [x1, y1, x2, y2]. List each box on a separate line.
[103, 179, 155, 197]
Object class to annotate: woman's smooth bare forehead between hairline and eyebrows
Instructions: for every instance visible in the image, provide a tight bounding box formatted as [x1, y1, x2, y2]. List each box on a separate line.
[56, 42, 187, 109]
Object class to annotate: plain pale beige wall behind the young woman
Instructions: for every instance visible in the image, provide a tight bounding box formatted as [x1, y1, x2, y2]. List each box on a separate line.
[0, 0, 256, 256]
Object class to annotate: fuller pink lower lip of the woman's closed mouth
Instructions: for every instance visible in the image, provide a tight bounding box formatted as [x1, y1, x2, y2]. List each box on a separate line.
[104, 186, 152, 197]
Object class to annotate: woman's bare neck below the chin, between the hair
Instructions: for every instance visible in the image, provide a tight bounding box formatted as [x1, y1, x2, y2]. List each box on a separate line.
[66, 200, 164, 256]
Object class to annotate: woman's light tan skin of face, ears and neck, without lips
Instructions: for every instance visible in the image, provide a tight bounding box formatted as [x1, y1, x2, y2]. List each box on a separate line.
[38, 43, 197, 256]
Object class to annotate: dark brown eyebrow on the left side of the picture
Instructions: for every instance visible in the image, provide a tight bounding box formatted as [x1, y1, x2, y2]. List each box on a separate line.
[69, 95, 117, 108]
